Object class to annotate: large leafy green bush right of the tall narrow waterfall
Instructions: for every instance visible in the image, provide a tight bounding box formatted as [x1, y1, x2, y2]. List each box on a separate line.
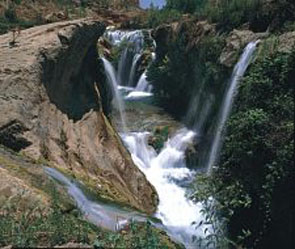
[194, 50, 295, 248]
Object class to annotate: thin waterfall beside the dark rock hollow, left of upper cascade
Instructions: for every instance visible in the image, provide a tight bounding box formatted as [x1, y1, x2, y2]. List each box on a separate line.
[102, 58, 127, 131]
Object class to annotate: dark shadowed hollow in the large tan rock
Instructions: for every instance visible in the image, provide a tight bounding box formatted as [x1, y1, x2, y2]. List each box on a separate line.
[41, 23, 100, 121]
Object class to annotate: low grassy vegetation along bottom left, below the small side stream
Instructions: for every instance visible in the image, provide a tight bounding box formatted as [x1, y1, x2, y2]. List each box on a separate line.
[0, 181, 177, 249]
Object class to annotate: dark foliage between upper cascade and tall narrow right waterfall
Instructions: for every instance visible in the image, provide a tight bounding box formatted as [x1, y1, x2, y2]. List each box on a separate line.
[148, 31, 228, 115]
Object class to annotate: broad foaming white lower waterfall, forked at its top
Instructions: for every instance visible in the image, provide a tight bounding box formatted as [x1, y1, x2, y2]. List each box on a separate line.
[122, 128, 210, 248]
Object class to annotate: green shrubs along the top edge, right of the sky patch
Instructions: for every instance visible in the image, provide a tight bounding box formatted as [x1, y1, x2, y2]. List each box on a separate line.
[147, 0, 295, 32]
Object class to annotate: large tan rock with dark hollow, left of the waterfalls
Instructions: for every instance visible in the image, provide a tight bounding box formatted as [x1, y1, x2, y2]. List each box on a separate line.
[0, 19, 157, 213]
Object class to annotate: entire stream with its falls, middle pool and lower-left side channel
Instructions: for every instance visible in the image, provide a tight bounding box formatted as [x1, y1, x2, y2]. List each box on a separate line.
[46, 30, 258, 249]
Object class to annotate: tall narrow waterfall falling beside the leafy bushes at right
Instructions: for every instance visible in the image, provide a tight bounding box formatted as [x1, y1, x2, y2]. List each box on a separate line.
[207, 40, 259, 173]
